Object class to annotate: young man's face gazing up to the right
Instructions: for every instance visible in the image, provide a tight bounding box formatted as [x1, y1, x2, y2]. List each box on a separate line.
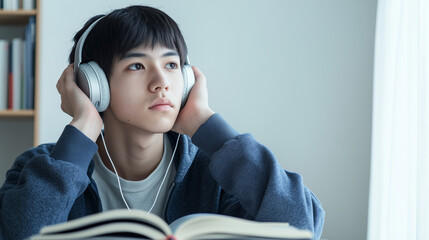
[105, 46, 183, 133]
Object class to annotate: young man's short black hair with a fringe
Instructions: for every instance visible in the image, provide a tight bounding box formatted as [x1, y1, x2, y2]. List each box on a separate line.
[69, 5, 188, 78]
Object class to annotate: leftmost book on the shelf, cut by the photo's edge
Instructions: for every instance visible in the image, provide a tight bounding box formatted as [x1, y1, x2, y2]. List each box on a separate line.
[0, 40, 9, 110]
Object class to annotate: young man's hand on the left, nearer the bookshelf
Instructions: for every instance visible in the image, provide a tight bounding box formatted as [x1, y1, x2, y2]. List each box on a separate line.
[57, 64, 103, 142]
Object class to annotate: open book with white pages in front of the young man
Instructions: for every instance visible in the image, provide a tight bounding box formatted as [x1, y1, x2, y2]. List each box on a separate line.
[30, 209, 312, 240]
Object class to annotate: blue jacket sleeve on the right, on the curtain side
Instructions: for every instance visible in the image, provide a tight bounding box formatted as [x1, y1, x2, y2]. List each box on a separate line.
[192, 114, 325, 239]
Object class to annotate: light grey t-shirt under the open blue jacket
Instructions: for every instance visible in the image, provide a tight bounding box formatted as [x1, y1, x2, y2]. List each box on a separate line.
[92, 135, 176, 218]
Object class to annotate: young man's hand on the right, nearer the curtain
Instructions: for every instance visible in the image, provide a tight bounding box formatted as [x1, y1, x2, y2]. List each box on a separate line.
[172, 66, 214, 137]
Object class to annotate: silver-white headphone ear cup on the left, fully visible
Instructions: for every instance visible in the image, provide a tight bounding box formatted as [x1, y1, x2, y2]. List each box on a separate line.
[76, 61, 110, 112]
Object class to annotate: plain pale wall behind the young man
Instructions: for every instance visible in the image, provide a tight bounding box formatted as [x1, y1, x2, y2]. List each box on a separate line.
[39, 0, 376, 240]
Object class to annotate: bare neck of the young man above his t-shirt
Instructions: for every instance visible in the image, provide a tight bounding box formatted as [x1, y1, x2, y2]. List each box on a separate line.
[97, 123, 164, 181]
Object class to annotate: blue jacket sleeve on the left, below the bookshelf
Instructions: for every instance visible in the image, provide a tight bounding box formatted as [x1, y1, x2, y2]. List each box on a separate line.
[0, 125, 97, 239]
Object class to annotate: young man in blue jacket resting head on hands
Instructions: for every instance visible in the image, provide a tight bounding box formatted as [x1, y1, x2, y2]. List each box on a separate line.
[0, 6, 324, 239]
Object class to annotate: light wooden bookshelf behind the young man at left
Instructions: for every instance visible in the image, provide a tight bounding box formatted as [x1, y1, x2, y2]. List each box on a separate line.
[0, 0, 40, 146]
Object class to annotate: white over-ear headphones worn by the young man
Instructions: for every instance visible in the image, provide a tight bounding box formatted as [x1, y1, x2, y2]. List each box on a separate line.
[74, 17, 195, 112]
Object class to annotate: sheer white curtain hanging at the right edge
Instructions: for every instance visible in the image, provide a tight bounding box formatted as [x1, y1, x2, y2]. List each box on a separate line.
[368, 0, 429, 240]
